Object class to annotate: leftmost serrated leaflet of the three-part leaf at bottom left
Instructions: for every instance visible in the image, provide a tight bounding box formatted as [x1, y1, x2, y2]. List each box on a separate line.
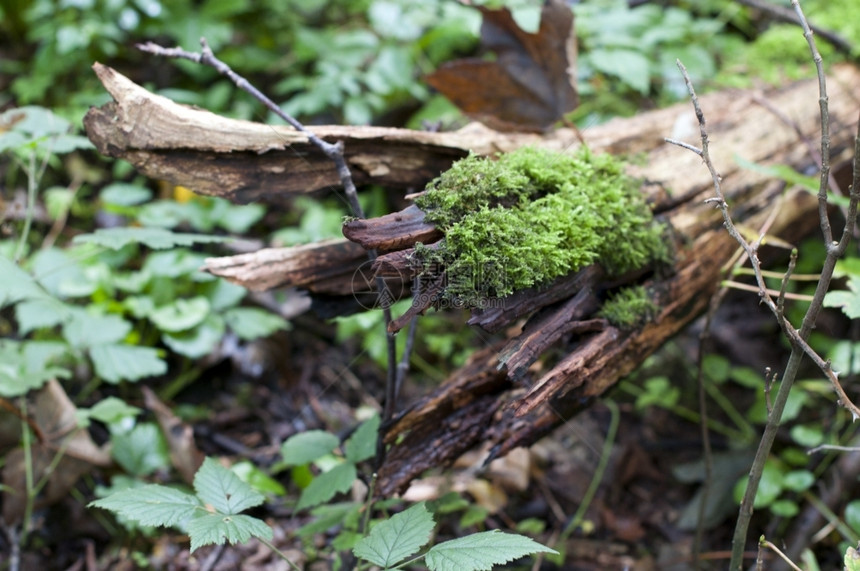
[88, 484, 202, 527]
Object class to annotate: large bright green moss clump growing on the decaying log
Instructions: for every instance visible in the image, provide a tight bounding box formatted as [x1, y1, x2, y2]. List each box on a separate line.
[415, 148, 668, 299]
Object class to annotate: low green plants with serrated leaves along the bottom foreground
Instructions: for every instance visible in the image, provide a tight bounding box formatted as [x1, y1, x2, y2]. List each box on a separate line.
[89, 415, 556, 571]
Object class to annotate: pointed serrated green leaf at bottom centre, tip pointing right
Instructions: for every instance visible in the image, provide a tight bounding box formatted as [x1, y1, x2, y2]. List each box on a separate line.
[424, 529, 558, 571]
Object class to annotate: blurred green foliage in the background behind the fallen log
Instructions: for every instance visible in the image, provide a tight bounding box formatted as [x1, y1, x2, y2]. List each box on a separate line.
[0, 0, 860, 568]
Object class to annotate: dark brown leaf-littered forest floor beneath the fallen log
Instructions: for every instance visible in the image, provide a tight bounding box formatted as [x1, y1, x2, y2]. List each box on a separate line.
[6, 282, 838, 571]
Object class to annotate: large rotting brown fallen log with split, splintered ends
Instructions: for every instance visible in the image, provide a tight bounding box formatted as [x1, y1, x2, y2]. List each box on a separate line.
[85, 61, 860, 494]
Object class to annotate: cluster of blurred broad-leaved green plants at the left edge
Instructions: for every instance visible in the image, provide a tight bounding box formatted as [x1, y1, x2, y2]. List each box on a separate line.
[0, 107, 287, 396]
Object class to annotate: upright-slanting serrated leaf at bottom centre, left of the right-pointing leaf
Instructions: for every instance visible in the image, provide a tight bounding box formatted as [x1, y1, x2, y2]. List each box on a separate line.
[352, 502, 435, 569]
